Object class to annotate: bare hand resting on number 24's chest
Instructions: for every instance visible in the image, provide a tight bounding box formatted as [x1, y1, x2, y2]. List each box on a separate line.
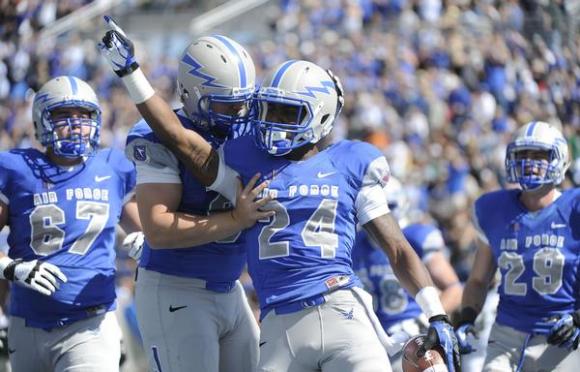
[232, 173, 276, 229]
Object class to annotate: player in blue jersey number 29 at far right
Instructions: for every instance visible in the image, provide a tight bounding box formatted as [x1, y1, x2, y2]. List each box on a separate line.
[457, 121, 580, 372]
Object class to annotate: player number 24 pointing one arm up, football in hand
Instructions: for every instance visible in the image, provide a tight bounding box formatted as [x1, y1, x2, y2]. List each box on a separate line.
[100, 19, 459, 371]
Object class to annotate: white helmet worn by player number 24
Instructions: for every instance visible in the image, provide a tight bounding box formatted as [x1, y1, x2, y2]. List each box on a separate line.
[254, 60, 342, 156]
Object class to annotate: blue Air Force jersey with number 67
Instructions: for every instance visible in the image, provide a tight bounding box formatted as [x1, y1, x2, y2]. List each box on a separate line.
[0, 149, 135, 329]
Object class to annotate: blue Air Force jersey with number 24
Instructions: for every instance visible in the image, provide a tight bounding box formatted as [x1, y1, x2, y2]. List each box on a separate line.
[214, 136, 388, 314]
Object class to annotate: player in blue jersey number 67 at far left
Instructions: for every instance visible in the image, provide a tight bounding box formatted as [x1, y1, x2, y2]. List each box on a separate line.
[0, 76, 141, 372]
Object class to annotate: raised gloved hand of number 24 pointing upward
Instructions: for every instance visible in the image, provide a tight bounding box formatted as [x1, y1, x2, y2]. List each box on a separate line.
[97, 16, 139, 77]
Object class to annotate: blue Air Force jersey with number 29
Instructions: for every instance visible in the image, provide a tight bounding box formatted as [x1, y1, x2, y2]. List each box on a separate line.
[474, 189, 580, 333]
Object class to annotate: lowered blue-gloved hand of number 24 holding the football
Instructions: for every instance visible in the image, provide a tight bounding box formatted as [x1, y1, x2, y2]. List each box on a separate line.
[419, 315, 461, 372]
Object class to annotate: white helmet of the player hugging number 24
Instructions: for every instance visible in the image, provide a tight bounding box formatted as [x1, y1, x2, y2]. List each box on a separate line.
[177, 35, 256, 138]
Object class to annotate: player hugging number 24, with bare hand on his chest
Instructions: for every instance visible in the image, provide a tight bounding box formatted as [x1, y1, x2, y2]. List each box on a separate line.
[126, 35, 272, 372]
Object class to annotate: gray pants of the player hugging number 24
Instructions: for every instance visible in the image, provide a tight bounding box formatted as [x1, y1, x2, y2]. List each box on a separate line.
[135, 268, 259, 372]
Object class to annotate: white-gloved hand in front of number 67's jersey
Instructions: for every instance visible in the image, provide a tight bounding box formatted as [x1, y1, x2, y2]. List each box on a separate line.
[3, 260, 67, 296]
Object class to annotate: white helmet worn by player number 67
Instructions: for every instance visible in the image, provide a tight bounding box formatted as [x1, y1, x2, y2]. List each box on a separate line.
[32, 76, 101, 158]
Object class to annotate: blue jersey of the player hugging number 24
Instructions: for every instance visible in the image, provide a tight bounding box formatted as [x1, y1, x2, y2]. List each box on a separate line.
[126, 111, 246, 292]
